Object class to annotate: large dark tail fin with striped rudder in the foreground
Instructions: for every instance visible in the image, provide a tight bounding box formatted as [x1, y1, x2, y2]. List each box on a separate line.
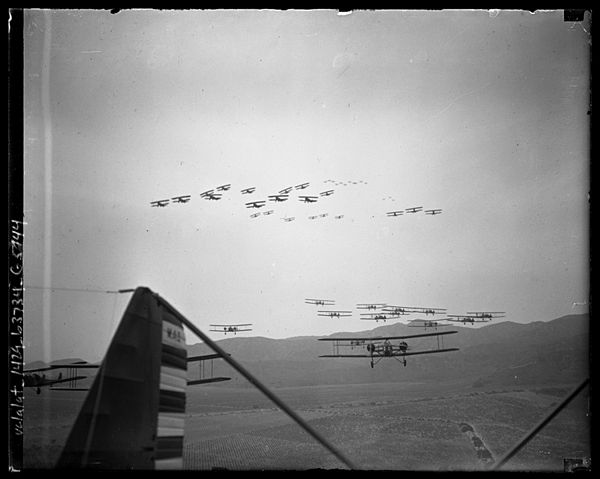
[57, 288, 187, 470]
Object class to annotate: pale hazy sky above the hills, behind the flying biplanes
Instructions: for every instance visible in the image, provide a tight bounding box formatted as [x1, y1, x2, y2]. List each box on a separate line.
[24, 10, 591, 361]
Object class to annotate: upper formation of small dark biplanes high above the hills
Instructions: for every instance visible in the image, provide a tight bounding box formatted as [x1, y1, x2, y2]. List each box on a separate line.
[150, 179, 443, 222]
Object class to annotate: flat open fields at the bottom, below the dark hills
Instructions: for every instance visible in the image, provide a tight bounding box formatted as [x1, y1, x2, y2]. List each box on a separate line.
[24, 382, 590, 471]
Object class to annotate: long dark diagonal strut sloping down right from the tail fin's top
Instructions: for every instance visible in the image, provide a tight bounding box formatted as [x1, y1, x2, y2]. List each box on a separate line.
[155, 293, 357, 469]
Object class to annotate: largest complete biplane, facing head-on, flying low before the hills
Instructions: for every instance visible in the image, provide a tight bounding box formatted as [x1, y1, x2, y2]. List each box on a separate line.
[319, 331, 458, 367]
